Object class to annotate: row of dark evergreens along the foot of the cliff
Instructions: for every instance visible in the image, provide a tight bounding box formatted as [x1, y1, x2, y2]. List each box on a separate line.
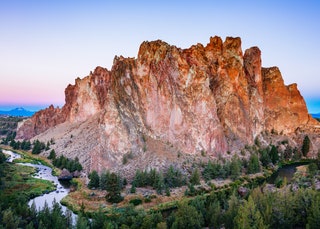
[88, 136, 310, 205]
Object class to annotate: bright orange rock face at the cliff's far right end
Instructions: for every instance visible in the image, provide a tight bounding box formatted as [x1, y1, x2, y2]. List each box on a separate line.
[262, 67, 317, 134]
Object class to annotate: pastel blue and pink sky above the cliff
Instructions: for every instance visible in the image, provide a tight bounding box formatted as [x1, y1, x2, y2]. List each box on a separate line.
[0, 0, 320, 113]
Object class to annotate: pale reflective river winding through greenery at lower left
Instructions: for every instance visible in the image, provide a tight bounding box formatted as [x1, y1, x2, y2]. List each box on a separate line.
[3, 150, 77, 222]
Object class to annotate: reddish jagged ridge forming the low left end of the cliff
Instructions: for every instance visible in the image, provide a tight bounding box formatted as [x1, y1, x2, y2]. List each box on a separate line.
[17, 67, 110, 139]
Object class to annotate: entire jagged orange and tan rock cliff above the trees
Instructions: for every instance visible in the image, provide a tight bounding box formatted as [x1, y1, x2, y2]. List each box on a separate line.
[17, 37, 314, 170]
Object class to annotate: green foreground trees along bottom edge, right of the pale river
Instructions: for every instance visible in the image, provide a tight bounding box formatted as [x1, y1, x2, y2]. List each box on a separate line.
[72, 155, 320, 229]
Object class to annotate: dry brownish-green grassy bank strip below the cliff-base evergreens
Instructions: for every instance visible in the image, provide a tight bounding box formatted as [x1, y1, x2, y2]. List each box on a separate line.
[61, 171, 271, 215]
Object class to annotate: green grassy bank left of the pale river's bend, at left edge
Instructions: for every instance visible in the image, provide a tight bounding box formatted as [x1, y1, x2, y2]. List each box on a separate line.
[0, 150, 60, 228]
